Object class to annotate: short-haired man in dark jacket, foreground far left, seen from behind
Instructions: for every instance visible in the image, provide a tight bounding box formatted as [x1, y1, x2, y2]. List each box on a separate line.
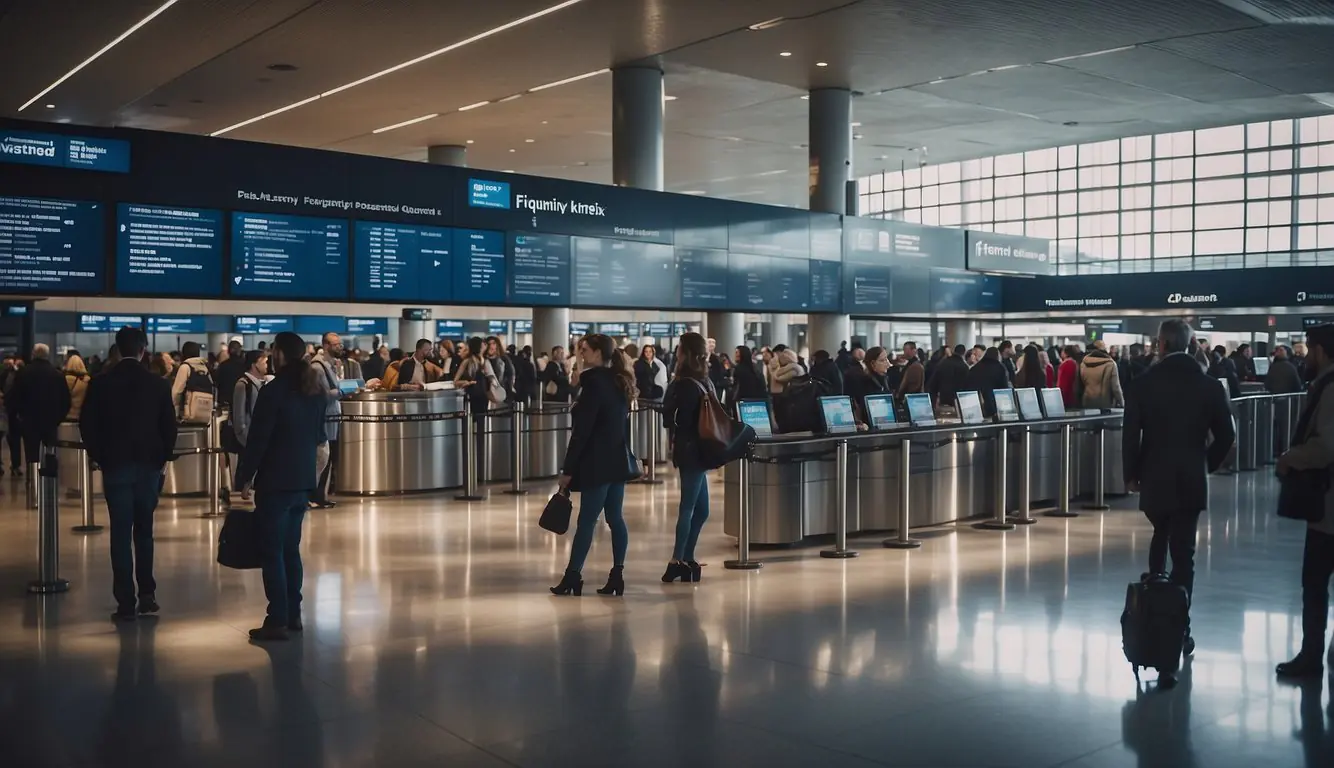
[79, 328, 176, 621]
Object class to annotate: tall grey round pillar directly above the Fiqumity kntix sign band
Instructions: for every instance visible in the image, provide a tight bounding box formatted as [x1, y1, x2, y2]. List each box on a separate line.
[611, 67, 663, 192]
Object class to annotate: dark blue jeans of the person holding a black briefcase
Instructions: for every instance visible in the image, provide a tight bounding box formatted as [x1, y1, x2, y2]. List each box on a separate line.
[255, 491, 309, 627]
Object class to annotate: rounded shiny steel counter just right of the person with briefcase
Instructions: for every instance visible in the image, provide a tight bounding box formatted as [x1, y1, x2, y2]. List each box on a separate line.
[335, 389, 463, 496]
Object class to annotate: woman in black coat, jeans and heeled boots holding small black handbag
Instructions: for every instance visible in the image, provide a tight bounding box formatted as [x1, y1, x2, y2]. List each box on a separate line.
[551, 333, 639, 595]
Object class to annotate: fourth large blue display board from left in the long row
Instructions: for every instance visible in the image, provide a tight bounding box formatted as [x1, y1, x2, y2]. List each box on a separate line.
[352, 221, 455, 301]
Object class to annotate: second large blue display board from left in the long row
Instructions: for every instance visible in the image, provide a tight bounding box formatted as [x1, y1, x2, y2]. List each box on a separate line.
[116, 203, 223, 296]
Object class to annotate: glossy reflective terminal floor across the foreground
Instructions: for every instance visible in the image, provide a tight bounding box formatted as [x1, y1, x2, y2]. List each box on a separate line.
[0, 472, 1334, 768]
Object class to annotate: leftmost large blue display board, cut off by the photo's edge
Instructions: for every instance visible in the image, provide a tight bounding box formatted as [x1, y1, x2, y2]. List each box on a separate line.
[0, 197, 105, 293]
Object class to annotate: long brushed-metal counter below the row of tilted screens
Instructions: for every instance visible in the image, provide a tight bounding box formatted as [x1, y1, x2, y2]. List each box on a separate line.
[723, 411, 1125, 544]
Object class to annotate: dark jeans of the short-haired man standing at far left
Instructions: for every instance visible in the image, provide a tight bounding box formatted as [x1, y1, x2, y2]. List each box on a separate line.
[101, 464, 161, 609]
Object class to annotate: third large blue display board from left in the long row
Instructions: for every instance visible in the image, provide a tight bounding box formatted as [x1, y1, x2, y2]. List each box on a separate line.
[231, 213, 348, 299]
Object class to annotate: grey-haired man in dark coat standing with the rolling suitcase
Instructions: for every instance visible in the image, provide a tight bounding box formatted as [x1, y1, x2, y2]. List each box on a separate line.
[1122, 320, 1237, 684]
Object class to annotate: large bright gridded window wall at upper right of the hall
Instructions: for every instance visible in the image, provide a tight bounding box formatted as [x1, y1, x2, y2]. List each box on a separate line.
[858, 115, 1334, 275]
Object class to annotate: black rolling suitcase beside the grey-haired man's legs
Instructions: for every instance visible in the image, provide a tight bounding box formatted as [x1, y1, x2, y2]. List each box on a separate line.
[1121, 573, 1190, 681]
